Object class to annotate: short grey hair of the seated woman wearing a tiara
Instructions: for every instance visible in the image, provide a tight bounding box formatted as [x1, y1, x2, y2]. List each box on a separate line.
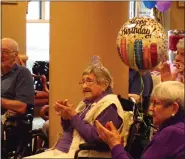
[82, 65, 113, 87]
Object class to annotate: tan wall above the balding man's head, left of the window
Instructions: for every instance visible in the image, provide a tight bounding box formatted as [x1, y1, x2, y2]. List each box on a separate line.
[1, 2, 27, 58]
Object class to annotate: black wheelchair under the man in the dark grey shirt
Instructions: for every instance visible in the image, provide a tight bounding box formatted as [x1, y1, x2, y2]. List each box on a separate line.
[2, 105, 33, 159]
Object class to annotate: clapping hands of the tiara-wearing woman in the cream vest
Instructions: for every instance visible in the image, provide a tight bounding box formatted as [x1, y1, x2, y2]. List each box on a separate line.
[53, 99, 77, 120]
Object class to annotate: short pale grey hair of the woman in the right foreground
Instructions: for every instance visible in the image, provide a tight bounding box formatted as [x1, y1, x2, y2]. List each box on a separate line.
[152, 81, 184, 111]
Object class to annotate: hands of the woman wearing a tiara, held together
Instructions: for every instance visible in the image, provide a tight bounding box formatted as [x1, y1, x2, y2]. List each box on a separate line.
[55, 99, 77, 120]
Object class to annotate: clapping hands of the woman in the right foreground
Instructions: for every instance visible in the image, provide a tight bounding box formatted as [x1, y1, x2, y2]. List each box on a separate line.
[95, 120, 123, 149]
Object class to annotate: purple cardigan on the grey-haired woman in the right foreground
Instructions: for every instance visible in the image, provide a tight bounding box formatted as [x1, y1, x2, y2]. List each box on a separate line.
[111, 113, 185, 159]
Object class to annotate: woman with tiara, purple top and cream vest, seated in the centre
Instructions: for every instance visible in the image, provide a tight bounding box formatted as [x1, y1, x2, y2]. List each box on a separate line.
[25, 57, 127, 158]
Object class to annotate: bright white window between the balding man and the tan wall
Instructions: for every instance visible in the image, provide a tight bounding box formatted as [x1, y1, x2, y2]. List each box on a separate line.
[26, 0, 50, 71]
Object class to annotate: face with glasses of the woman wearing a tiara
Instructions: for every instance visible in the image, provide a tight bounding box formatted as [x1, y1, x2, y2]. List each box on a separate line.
[80, 73, 105, 101]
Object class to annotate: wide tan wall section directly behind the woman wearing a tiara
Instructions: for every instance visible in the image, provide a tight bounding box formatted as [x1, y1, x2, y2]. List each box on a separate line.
[49, 2, 128, 146]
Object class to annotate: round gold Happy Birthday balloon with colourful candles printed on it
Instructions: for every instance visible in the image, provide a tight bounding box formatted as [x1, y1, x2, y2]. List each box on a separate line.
[117, 17, 167, 71]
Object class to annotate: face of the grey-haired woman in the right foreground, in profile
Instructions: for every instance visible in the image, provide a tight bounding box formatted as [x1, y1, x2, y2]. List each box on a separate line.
[149, 99, 173, 127]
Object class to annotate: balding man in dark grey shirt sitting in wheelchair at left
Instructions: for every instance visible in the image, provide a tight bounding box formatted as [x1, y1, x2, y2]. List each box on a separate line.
[1, 38, 34, 158]
